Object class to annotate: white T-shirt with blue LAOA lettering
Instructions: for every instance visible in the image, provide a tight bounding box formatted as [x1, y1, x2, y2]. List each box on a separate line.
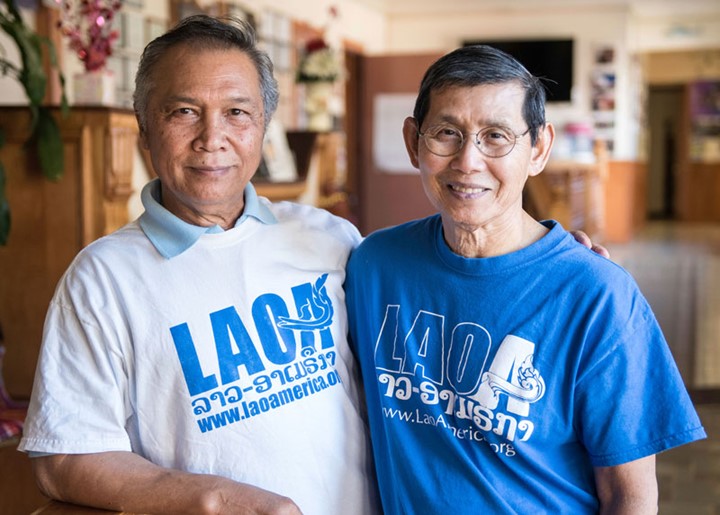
[19, 198, 376, 515]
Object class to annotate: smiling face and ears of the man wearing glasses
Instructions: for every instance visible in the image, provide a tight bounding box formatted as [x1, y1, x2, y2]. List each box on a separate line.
[403, 82, 554, 255]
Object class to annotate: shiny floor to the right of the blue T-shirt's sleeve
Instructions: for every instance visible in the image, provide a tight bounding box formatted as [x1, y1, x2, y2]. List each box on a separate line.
[608, 222, 720, 515]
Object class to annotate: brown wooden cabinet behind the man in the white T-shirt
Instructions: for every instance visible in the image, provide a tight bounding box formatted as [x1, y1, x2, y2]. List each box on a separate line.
[0, 107, 138, 398]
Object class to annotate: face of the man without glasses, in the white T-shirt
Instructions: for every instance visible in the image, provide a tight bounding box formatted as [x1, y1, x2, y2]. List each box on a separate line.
[141, 45, 265, 228]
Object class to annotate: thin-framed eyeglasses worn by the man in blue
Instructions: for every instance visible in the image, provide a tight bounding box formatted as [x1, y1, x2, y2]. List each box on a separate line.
[418, 124, 530, 157]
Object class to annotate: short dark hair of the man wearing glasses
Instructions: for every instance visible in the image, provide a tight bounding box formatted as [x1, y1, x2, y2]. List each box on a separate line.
[413, 45, 545, 145]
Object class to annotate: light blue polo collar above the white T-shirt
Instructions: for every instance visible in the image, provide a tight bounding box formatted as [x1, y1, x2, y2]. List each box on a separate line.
[139, 179, 277, 259]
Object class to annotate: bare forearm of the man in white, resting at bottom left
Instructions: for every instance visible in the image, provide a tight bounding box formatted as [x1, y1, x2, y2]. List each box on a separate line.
[32, 451, 301, 515]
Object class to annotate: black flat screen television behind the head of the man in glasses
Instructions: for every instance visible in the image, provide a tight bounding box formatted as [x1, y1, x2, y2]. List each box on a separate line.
[463, 39, 573, 102]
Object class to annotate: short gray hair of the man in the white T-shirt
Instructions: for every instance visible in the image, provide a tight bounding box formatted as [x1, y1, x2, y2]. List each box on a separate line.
[133, 14, 280, 130]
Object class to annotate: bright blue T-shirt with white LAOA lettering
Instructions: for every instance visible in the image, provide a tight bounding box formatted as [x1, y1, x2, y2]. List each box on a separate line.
[346, 215, 705, 515]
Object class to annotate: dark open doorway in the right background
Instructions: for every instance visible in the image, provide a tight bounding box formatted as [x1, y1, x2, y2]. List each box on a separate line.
[647, 85, 684, 220]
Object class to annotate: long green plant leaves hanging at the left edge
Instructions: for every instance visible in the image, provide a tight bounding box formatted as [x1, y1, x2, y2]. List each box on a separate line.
[0, 0, 68, 245]
